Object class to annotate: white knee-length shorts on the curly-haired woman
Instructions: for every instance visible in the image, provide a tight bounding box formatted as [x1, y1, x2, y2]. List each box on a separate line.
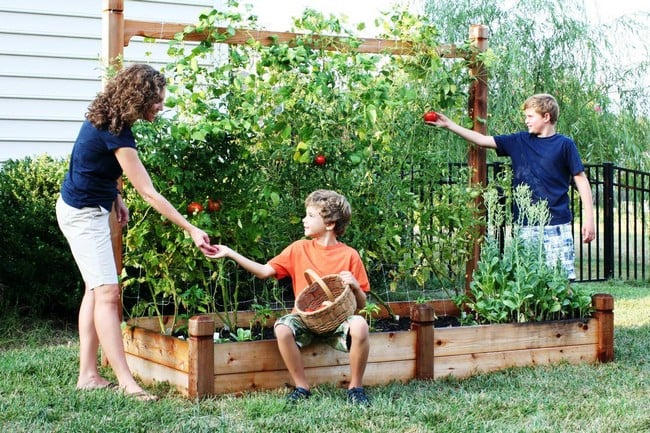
[56, 197, 118, 289]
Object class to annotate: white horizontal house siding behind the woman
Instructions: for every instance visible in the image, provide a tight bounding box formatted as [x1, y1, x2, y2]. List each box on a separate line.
[0, 0, 222, 163]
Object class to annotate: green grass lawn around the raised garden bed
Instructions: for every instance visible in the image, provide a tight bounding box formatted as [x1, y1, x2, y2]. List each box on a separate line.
[0, 282, 650, 433]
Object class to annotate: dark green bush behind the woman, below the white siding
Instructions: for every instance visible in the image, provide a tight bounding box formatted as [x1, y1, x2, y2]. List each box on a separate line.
[0, 155, 83, 317]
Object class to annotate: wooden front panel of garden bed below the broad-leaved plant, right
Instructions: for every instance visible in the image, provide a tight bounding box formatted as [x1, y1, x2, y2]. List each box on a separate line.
[433, 319, 598, 378]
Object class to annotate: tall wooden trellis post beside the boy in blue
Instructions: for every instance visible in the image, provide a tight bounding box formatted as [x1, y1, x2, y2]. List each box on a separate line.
[465, 24, 488, 290]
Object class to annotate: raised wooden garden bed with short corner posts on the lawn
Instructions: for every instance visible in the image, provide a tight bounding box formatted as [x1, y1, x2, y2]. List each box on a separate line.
[123, 295, 614, 398]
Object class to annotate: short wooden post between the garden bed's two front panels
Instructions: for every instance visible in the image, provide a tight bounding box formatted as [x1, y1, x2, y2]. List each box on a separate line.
[411, 304, 436, 379]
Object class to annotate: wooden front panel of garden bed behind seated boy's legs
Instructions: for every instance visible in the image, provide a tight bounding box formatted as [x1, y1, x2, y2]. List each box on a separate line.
[214, 331, 415, 394]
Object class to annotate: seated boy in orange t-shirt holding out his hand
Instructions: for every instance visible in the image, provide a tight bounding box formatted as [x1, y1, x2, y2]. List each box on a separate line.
[209, 190, 370, 405]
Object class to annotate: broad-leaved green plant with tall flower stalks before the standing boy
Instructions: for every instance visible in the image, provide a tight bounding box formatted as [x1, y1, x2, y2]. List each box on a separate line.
[455, 181, 591, 324]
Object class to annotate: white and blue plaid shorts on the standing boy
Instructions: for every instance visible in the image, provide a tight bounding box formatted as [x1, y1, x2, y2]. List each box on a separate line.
[519, 223, 576, 280]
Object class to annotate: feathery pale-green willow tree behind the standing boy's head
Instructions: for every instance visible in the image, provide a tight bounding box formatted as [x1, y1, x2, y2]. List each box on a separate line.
[425, 0, 650, 170]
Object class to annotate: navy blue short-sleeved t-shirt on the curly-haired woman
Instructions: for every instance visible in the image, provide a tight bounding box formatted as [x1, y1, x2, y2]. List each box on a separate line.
[61, 120, 136, 211]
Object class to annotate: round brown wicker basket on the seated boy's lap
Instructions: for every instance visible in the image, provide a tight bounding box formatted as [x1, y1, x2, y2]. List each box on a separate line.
[296, 269, 357, 334]
